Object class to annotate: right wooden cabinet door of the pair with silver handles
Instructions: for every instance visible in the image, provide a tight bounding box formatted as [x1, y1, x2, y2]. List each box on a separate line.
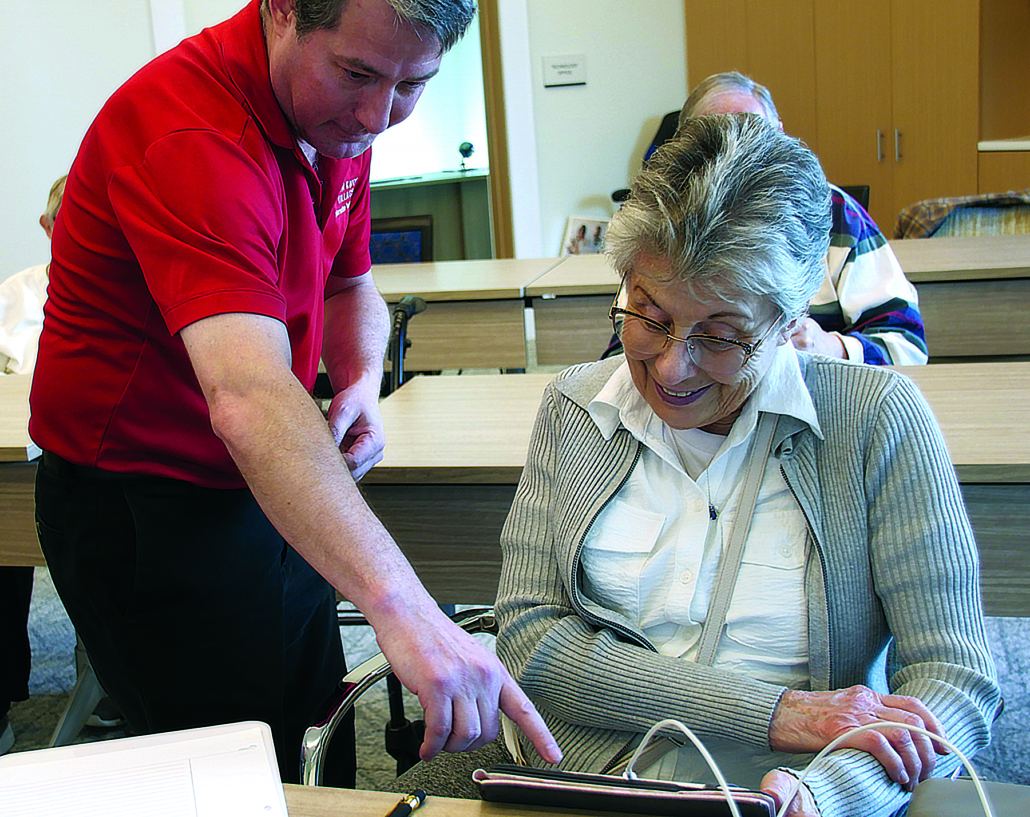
[891, 0, 980, 219]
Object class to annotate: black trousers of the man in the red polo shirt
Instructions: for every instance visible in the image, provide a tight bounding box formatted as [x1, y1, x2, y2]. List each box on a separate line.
[36, 452, 354, 786]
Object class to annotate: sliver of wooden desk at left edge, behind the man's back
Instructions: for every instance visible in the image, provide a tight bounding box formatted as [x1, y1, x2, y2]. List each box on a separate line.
[0, 374, 43, 566]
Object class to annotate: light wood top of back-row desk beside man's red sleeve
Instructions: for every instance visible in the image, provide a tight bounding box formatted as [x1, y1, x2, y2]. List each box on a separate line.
[372, 259, 562, 303]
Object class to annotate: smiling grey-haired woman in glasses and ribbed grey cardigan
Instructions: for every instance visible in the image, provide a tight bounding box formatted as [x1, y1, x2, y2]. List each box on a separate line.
[497, 114, 999, 817]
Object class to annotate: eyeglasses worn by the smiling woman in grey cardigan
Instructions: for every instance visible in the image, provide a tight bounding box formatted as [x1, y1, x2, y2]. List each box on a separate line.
[608, 287, 782, 377]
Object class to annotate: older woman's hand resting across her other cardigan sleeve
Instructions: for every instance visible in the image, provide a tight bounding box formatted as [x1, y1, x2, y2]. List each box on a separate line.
[769, 686, 948, 791]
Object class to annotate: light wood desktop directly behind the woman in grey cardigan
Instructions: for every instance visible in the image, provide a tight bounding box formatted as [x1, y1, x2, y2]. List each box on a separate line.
[365, 362, 1030, 484]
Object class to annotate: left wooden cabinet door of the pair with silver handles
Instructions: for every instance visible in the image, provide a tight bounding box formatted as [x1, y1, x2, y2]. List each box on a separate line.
[815, 0, 894, 226]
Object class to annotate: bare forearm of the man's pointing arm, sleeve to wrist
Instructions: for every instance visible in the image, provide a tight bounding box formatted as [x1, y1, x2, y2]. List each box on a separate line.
[182, 314, 427, 623]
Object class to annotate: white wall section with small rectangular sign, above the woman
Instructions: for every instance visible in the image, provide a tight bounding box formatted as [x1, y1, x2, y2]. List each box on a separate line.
[519, 0, 687, 256]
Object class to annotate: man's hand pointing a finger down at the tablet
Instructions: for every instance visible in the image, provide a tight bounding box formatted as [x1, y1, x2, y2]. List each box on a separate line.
[376, 608, 561, 763]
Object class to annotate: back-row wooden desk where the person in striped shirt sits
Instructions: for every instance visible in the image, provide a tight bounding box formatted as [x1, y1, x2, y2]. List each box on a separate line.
[525, 235, 1030, 364]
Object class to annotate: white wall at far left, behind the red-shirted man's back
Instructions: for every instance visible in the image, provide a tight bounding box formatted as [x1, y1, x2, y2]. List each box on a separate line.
[0, 0, 155, 279]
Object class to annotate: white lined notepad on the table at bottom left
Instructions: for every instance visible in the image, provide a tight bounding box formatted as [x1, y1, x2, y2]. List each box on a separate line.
[0, 721, 287, 817]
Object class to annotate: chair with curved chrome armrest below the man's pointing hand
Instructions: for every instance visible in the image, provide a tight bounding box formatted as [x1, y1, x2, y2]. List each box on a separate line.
[301, 607, 497, 786]
